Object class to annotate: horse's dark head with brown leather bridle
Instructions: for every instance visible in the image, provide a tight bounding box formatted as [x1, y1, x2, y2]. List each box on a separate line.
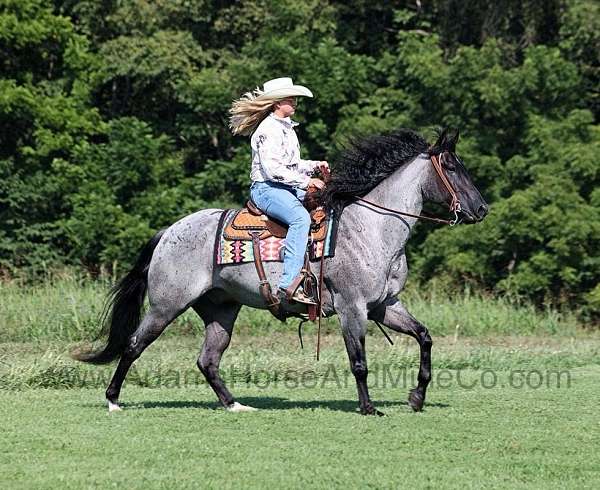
[427, 129, 488, 223]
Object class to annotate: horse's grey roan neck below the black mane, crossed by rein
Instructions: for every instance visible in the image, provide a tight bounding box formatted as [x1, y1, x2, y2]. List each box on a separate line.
[341, 155, 430, 254]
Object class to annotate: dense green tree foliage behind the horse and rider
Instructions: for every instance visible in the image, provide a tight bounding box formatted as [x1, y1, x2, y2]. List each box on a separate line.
[0, 0, 600, 316]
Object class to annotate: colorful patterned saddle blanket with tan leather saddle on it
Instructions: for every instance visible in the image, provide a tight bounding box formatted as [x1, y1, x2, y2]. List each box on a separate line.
[215, 208, 336, 264]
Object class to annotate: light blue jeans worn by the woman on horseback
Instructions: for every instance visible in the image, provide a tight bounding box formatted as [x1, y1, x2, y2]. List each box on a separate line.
[250, 182, 310, 289]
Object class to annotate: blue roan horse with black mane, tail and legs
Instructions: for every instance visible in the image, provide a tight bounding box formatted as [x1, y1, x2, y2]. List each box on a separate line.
[75, 130, 488, 414]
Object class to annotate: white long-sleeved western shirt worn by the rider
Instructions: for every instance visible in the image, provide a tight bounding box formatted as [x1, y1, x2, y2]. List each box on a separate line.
[250, 113, 320, 189]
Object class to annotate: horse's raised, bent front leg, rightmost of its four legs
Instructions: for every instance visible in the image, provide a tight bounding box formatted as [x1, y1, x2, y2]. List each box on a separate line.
[369, 298, 433, 412]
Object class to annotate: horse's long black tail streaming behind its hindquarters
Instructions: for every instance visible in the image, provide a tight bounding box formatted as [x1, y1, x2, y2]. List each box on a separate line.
[73, 230, 165, 364]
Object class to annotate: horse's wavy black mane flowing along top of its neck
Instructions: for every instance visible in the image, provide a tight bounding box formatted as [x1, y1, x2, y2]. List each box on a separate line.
[322, 128, 458, 208]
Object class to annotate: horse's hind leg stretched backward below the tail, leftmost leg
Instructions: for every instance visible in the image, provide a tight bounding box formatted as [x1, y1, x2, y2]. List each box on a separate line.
[106, 307, 179, 412]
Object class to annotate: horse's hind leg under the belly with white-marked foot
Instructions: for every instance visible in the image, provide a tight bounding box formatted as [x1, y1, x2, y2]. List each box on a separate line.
[193, 298, 254, 412]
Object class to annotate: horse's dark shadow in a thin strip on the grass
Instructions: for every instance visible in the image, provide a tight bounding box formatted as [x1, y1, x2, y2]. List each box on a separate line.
[117, 396, 449, 413]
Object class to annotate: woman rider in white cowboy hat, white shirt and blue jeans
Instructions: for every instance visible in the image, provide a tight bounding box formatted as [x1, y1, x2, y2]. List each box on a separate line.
[229, 78, 328, 304]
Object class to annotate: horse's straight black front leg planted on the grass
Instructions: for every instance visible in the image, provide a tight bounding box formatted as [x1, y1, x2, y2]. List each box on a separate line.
[338, 305, 383, 415]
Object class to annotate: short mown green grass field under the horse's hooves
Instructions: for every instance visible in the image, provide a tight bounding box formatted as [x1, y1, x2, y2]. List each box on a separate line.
[0, 328, 600, 489]
